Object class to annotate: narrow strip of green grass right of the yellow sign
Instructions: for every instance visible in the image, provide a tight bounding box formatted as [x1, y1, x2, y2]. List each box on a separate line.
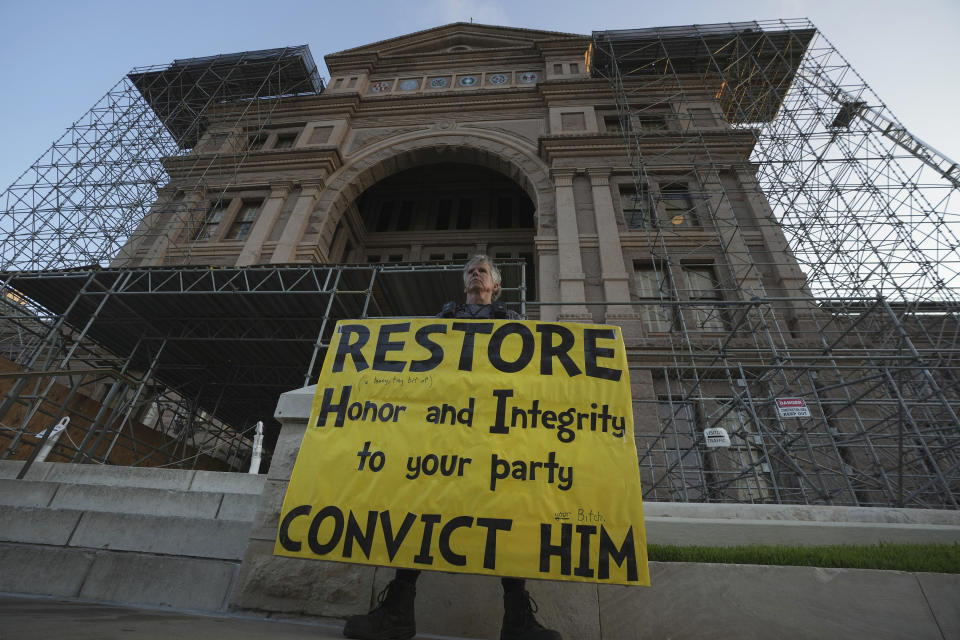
[647, 543, 960, 573]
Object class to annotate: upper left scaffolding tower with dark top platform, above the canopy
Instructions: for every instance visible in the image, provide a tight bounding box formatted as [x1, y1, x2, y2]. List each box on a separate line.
[0, 45, 323, 271]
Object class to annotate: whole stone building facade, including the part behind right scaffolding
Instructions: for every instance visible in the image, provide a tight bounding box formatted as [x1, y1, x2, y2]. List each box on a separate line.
[107, 23, 952, 505]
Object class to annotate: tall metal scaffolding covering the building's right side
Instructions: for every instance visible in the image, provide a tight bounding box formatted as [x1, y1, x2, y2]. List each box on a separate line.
[589, 20, 960, 508]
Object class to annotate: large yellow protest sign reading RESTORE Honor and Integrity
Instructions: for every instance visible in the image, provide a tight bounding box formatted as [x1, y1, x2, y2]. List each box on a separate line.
[274, 318, 650, 585]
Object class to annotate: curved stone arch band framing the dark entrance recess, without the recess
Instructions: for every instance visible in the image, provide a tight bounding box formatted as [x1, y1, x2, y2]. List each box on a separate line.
[310, 129, 555, 252]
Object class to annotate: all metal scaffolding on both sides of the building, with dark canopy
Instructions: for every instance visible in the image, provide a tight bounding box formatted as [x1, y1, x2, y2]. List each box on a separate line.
[0, 20, 960, 508]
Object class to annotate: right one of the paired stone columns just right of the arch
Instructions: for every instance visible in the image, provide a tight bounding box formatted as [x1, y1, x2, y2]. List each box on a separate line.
[587, 169, 643, 338]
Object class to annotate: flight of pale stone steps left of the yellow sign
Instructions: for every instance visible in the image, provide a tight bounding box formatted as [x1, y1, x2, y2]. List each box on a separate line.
[0, 461, 266, 611]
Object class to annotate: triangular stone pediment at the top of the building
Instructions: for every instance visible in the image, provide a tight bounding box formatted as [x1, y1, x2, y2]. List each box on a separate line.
[327, 22, 587, 59]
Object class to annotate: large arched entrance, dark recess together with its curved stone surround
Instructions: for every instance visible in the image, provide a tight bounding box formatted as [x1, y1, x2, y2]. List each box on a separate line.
[313, 132, 554, 308]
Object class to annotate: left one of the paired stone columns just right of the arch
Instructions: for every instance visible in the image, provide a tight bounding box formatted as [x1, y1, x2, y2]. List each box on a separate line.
[553, 169, 593, 322]
